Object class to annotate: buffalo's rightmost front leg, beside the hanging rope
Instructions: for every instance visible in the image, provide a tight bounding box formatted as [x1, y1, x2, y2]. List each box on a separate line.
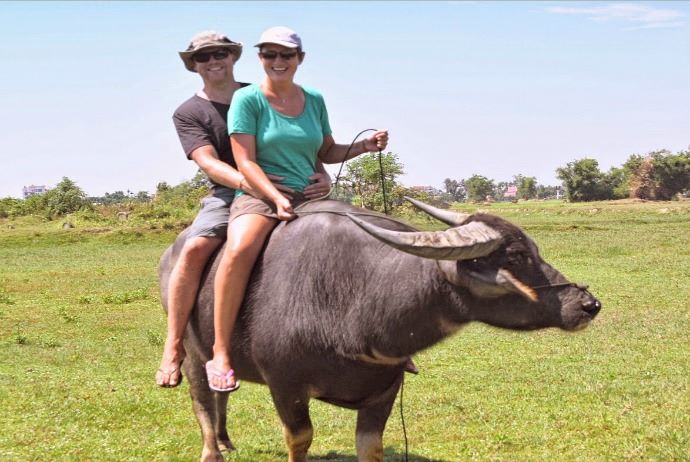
[356, 394, 395, 462]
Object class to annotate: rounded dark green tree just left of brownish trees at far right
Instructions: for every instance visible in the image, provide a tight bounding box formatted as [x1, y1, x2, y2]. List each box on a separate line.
[556, 158, 612, 202]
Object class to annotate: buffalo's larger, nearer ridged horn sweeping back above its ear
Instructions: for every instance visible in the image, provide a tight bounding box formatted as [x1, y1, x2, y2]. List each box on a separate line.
[347, 213, 502, 260]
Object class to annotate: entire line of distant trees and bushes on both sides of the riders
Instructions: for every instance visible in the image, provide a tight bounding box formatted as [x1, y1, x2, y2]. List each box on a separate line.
[0, 149, 690, 219]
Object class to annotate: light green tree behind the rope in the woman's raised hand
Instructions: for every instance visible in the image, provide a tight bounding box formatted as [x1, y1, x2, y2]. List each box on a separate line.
[341, 152, 404, 211]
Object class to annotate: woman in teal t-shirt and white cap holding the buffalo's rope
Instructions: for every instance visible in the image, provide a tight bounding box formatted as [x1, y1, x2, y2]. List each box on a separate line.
[206, 26, 388, 392]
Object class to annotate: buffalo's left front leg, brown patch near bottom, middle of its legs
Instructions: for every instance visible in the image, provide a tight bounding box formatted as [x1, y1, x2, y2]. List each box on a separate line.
[271, 390, 314, 462]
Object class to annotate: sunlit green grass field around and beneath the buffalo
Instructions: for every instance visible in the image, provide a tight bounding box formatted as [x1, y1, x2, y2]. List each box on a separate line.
[0, 201, 690, 462]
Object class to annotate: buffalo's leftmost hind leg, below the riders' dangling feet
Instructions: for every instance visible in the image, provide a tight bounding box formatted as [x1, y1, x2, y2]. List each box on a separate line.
[183, 356, 225, 462]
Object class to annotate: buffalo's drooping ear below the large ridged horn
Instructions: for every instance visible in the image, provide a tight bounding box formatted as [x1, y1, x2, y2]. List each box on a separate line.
[438, 261, 539, 303]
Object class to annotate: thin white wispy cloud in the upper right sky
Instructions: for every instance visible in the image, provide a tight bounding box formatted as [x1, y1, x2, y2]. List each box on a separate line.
[547, 3, 685, 29]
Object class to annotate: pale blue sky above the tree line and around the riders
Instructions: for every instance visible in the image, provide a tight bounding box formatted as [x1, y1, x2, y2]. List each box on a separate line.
[0, 1, 690, 197]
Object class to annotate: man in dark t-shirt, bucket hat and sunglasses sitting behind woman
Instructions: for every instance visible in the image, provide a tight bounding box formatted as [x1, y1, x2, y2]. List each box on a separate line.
[156, 31, 330, 387]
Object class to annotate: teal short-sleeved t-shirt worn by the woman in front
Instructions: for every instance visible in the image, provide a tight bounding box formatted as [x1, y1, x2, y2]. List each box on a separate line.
[228, 84, 331, 192]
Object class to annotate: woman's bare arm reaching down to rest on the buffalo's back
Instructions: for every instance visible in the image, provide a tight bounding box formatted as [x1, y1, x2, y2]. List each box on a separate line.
[230, 133, 295, 220]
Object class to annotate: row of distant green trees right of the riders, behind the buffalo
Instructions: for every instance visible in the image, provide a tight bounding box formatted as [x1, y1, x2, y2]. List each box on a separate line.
[338, 149, 690, 210]
